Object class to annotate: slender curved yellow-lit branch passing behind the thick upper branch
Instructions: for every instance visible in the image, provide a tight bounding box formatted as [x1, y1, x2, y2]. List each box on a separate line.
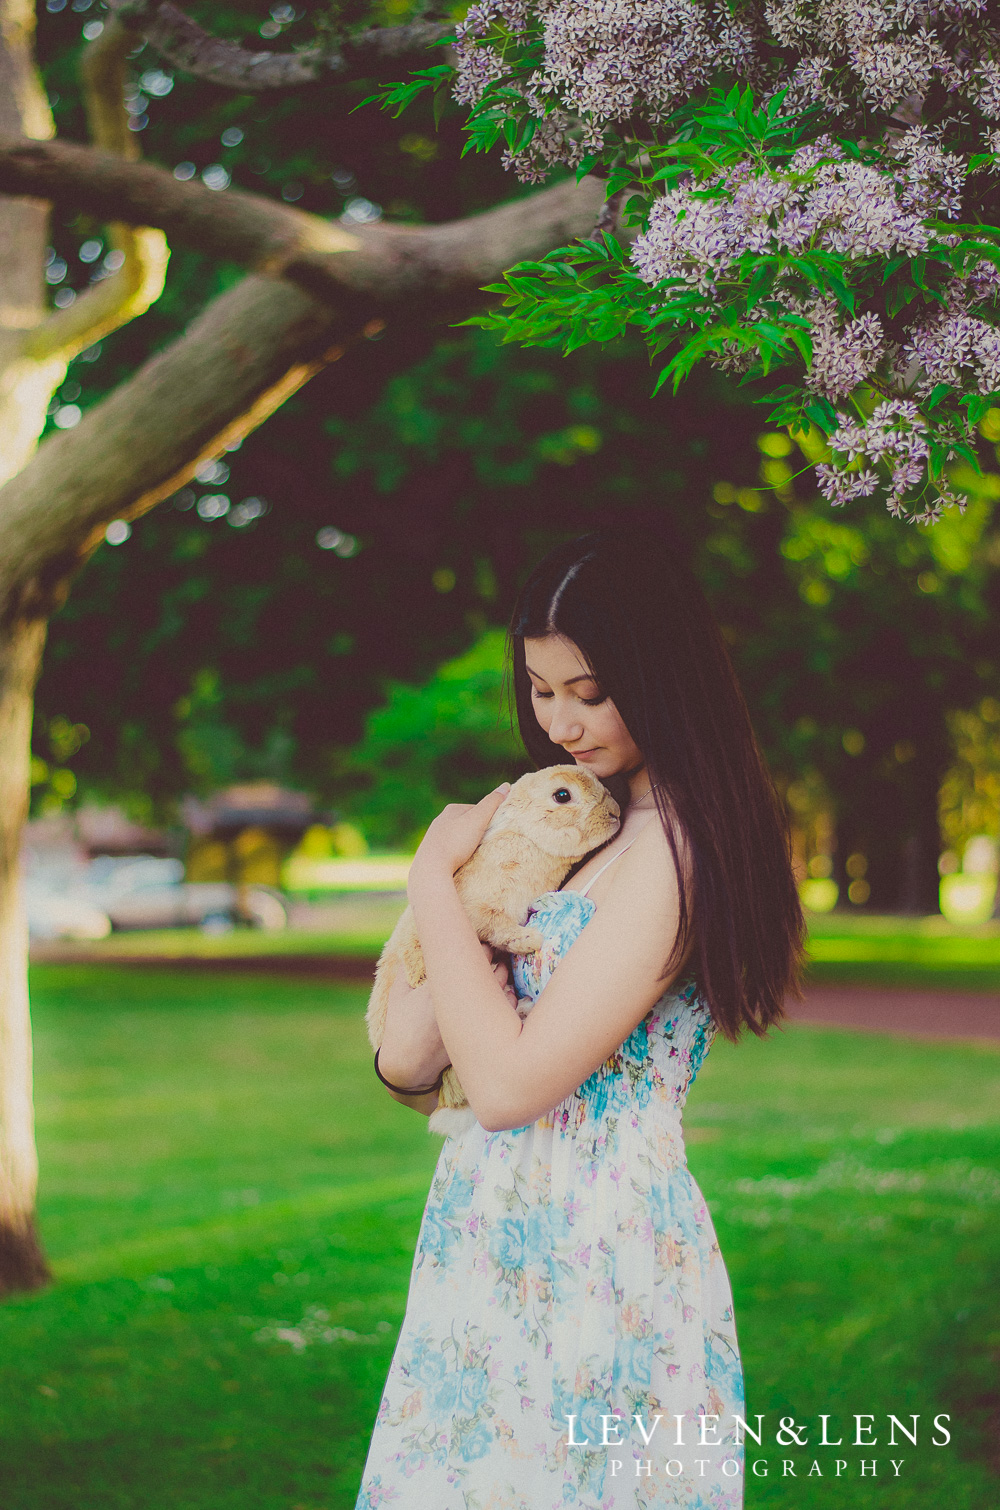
[24, 17, 171, 362]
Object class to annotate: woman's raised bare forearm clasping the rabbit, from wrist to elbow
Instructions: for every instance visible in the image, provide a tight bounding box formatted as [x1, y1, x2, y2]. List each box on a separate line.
[412, 868, 523, 1129]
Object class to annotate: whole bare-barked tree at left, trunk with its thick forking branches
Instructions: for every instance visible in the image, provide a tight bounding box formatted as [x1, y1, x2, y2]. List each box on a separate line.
[0, 0, 603, 1294]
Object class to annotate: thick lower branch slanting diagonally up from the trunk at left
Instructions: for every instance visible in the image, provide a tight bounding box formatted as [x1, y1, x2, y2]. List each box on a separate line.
[0, 278, 362, 622]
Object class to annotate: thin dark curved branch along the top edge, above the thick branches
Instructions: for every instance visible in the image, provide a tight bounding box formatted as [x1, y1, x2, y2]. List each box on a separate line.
[110, 0, 455, 94]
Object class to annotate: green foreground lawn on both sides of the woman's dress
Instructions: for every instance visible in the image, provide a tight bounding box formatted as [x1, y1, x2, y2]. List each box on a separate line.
[0, 965, 1000, 1510]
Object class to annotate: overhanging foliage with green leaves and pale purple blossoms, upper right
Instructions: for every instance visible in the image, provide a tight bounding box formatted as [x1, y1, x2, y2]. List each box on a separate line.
[370, 0, 1000, 524]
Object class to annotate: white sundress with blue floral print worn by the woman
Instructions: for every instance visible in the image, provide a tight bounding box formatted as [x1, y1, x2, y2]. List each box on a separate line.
[356, 891, 745, 1510]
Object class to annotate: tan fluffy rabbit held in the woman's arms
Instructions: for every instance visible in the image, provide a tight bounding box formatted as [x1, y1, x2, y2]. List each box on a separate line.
[366, 766, 619, 1136]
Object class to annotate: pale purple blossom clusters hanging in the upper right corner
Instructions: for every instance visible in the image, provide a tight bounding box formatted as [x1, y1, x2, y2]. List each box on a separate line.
[455, 0, 1000, 522]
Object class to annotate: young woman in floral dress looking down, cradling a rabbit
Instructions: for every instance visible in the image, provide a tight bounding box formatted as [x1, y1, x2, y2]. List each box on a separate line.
[358, 533, 802, 1510]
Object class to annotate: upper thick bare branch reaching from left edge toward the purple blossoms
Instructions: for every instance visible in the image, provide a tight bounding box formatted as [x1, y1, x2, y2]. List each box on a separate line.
[0, 137, 604, 308]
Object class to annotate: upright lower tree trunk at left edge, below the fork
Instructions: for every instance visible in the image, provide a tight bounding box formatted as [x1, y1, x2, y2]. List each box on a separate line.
[0, 607, 48, 1296]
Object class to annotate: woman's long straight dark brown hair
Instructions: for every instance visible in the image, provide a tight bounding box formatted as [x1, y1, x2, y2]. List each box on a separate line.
[511, 527, 804, 1042]
